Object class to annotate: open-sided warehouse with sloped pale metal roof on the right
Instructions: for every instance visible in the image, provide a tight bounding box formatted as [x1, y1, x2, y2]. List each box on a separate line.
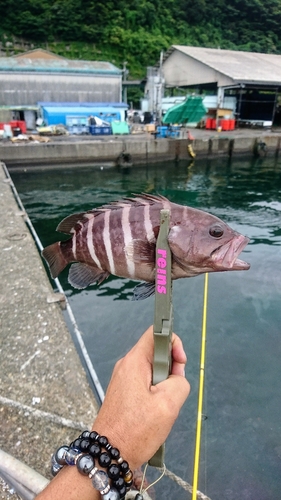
[161, 45, 281, 124]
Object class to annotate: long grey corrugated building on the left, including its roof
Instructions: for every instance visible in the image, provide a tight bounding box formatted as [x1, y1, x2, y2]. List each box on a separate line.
[0, 49, 122, 128]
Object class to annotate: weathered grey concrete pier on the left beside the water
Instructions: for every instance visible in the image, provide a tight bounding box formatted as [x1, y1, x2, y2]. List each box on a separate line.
[0, 164, 98, 499]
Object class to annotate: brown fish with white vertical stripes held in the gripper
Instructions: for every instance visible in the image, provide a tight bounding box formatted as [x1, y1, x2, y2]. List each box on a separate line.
[42, 193, 250, 300]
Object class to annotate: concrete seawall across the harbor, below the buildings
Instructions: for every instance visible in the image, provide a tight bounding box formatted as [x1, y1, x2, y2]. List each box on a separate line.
[0, 129, 281, 168]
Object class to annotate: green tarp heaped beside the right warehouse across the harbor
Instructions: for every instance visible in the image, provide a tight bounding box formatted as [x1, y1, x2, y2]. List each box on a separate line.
[162, 96, 207, 124]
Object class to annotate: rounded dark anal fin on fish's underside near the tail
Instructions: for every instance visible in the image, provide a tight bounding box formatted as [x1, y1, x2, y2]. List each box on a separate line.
[68, 262, 109, 290]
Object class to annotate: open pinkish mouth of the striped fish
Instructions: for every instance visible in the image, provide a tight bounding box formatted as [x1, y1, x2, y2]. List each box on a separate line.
[211, 234, 250, 271]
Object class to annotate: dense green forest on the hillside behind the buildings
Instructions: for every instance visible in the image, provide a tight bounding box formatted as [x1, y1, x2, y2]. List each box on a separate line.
[0, 0, 281, 79]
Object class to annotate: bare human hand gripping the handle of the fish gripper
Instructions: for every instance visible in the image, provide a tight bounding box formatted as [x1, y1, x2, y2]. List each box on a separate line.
[93, 327, 190, 470]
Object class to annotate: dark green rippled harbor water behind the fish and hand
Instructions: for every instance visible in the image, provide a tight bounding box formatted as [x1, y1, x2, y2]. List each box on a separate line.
[10, 158, 281, 500]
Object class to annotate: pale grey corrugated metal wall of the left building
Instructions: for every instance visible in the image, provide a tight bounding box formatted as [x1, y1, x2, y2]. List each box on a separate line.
[0, 73, 119, 106]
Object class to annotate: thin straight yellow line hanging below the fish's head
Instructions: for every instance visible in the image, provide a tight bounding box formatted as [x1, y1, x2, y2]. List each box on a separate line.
[192, 273, 208, 500]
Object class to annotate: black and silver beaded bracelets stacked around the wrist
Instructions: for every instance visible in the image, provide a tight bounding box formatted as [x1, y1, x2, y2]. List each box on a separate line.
[52, 431, 133, 500]
